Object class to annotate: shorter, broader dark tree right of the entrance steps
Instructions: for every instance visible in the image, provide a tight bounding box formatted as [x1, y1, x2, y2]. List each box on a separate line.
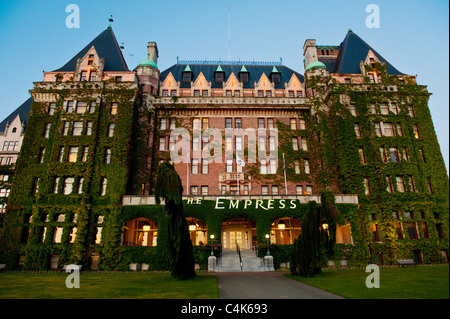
[291, 191, 342, 277]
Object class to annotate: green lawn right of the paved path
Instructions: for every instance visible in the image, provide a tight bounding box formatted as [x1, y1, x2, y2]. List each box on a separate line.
[286, 265, 449, 299]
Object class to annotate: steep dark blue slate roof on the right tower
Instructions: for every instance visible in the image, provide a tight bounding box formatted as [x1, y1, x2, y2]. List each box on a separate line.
[319, 30, 404, 75]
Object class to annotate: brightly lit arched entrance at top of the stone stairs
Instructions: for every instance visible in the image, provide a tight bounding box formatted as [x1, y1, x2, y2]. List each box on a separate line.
[222, 217, 256, 249]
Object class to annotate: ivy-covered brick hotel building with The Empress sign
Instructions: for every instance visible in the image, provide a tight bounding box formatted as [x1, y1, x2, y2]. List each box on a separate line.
[0, 28, 449, 270]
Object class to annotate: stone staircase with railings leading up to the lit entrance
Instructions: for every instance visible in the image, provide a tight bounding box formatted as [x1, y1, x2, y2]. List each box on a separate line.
[215, 249, 273, 272]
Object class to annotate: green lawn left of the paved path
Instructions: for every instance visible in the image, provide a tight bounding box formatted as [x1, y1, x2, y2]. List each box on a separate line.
[0, 272, 219, 299]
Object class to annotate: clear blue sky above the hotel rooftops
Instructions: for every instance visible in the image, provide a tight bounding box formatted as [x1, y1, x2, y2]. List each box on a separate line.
[0, 0, 449, 170]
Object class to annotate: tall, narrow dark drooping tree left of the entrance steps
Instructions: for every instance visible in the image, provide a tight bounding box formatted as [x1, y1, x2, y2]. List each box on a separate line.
[155, 163, 195, 280]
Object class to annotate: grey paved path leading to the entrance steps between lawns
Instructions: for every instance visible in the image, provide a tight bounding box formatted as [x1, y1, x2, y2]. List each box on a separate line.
[214, 272, 344, 299]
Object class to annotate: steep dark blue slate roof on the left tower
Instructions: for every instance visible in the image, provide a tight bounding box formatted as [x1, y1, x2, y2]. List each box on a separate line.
[54, 27, 129, 72]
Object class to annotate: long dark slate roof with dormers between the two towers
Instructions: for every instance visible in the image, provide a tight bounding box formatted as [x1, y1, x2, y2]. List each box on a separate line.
[160, 64, 304, 89]
